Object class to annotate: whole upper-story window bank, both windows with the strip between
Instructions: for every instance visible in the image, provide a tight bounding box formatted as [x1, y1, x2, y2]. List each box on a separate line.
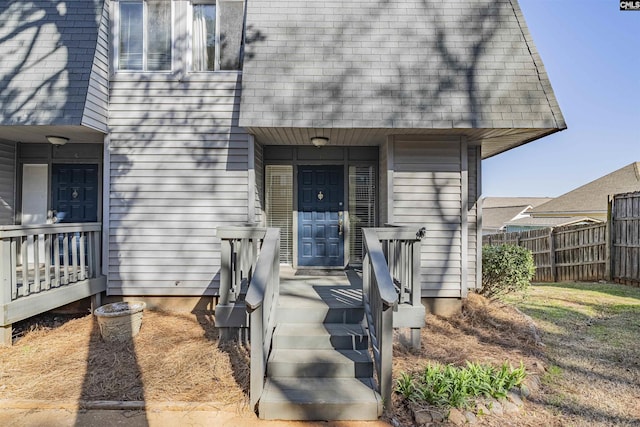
[112, 0, 246, 75]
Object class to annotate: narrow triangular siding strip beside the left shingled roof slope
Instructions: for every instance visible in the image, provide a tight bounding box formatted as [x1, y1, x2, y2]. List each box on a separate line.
[82, 1, 109, 133]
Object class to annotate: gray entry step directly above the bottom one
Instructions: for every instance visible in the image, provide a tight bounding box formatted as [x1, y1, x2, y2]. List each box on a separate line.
[267, 349, 373, 378]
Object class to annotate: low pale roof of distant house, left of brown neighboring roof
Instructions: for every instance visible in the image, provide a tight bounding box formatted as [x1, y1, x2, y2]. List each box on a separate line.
[482, 197, 551, 231]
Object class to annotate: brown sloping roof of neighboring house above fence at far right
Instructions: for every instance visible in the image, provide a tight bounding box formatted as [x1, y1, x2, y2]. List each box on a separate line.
[530, 162, 640, 216]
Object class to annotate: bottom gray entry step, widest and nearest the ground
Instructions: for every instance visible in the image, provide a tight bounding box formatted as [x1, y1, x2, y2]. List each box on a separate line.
[258, 377, 382, 420]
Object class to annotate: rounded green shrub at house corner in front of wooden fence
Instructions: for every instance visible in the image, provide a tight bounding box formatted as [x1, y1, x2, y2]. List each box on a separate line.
[480, 245, 536, 298]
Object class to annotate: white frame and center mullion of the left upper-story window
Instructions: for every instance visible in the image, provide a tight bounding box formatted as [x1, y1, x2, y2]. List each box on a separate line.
[112, 0, 176, 74]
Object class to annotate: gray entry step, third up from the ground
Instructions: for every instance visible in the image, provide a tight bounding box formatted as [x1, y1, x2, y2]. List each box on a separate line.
[273, 323, 369, 350]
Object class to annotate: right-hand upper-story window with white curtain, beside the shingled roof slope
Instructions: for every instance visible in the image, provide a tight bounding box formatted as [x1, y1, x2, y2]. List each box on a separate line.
[191, 0, 244, 71]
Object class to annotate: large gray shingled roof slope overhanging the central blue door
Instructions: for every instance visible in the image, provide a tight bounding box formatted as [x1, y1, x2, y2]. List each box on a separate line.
[239, 0, 566, 158]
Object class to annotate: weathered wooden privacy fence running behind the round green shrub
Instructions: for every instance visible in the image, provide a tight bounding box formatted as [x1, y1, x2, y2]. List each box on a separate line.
[482, 192, 640, 286]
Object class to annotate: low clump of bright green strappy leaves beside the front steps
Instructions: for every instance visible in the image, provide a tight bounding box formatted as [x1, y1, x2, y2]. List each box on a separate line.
[395, 362, 526, 408]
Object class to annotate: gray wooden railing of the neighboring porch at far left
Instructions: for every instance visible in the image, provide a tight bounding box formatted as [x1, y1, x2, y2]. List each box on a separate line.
[0, 223, 106, 343]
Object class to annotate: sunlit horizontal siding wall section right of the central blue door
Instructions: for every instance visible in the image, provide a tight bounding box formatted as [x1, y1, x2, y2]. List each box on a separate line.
[391, 136, 463, 297]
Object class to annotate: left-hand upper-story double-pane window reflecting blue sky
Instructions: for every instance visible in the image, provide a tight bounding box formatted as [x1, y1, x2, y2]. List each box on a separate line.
[118, 0, 172, 71]
